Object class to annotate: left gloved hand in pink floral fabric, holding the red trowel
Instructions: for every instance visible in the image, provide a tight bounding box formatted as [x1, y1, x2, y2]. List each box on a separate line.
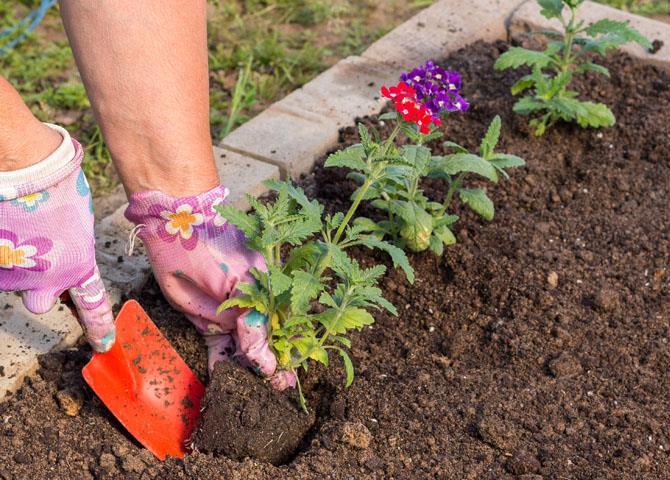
[0, 125, 115, 352]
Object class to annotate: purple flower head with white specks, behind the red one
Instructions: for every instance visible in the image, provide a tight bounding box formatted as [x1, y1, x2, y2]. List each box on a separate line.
[400, 61, 469, 117]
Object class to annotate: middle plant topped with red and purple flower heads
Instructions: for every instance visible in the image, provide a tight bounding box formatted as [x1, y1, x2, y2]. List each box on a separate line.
[338, 62, 525, 255]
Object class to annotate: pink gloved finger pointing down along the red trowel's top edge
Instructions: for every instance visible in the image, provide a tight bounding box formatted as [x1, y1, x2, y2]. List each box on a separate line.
[69, 266, 116, 353]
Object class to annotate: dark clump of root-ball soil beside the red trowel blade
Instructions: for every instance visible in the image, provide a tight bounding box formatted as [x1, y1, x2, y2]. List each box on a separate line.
[194, 362, 316, 465]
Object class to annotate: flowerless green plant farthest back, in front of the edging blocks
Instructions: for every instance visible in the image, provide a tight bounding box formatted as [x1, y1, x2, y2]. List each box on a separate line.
[495, 0, 652, 137]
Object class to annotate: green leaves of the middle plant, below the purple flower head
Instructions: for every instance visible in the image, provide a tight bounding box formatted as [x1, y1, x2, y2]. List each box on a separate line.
[352, 114, 525, 256]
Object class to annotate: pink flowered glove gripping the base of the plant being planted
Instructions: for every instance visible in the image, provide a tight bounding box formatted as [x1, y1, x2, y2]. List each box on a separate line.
[126, 186, 295, 389]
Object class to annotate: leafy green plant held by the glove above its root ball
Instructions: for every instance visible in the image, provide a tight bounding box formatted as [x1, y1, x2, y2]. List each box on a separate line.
[217, 178, 414, 411]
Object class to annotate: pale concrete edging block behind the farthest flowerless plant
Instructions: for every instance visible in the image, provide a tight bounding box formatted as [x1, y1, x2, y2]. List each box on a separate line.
[509, 0, 670, 69]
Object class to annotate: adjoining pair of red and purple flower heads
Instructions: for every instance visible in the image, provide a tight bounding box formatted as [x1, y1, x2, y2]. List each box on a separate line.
[381, 61, 469, 134]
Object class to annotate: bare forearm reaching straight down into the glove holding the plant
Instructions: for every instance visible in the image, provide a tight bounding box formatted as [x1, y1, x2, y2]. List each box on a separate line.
[61, 0, 218, 196]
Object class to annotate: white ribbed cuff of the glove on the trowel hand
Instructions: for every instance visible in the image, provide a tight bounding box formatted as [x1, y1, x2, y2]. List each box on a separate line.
[0, 123, 84, 201]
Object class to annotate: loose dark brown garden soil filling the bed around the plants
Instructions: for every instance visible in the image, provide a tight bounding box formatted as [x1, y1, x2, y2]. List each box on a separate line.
[0, 43, 670, 480]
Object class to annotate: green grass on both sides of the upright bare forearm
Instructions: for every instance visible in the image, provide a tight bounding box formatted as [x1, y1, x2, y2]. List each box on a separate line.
[0, 0, 434, 195]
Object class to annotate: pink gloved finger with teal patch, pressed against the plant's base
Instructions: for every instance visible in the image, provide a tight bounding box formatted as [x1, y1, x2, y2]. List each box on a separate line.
[237, 309, 277, 377]
